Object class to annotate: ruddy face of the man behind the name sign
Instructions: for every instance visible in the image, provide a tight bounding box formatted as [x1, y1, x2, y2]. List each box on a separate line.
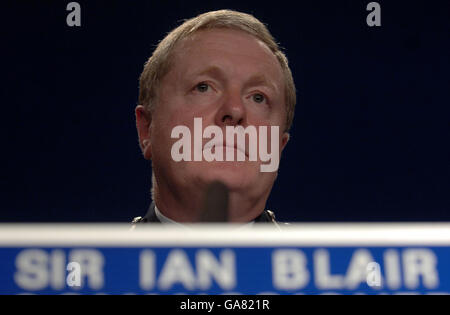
[142, 29, 288, 202]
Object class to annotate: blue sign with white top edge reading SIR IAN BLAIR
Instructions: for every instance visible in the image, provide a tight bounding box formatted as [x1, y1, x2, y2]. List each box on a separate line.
[0, 224, 450, 295]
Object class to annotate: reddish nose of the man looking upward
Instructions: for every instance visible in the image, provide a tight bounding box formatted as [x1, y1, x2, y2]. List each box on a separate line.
[215, 92, 247, 126]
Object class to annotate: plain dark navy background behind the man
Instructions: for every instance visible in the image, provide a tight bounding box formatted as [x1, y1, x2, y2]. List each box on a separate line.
[0, 0, 450, 222]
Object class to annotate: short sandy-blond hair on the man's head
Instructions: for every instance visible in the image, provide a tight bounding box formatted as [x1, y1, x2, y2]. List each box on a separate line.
[139, 10, 296, 131]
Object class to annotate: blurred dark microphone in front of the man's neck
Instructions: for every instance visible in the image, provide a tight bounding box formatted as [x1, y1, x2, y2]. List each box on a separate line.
[199, 181, 230, 223]
